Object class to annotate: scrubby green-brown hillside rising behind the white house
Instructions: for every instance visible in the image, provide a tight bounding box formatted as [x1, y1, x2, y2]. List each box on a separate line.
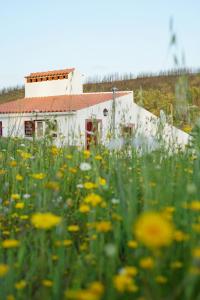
[0, 74, 200, 131]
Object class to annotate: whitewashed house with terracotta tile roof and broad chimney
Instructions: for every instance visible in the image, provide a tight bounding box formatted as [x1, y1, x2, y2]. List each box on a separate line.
[0, 68, 189, 148]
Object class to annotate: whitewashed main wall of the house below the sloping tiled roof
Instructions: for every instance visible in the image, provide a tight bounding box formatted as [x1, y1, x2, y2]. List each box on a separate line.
[0, 92, 190, 147]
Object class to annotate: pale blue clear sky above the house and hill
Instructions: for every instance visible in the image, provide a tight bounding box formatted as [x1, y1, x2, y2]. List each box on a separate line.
[0, 0, 200, 88]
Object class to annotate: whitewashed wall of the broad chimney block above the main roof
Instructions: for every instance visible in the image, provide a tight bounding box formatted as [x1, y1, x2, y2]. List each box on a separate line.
[25, 70, 83, 98]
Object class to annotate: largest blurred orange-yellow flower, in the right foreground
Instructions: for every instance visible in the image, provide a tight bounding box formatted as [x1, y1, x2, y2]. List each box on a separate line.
[134, 212, 173, 248]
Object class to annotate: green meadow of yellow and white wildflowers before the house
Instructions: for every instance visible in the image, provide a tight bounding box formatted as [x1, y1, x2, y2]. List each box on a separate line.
[0, 139, 200, 300]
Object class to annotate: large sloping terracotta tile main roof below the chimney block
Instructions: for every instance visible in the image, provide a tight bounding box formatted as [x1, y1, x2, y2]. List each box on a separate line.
[0, 92, 130, 114]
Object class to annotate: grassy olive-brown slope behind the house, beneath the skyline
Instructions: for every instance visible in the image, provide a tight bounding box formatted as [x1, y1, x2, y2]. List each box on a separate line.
[0, 74, 200, 128]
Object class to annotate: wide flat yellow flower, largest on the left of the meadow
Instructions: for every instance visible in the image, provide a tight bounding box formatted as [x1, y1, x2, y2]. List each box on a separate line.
[31, 213, 61, 230]
